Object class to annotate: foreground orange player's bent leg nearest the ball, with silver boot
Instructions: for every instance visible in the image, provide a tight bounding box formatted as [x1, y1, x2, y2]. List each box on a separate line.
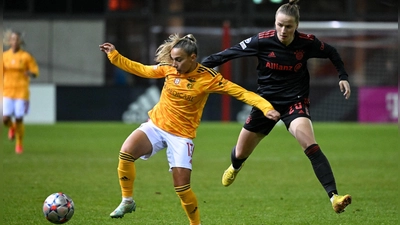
[110, 122, 157, 218]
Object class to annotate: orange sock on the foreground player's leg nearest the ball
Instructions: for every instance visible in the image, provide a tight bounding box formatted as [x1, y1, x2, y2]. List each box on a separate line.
[118, 152, 136, 197]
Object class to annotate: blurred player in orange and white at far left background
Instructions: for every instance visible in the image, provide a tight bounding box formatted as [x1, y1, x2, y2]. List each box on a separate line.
[3, 30, 39, 154]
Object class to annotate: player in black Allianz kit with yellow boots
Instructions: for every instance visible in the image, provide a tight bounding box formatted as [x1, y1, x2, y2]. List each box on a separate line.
[202, 0, 351, 213]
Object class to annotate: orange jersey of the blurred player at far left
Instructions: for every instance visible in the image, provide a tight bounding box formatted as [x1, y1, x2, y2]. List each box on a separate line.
[3, 49, 39, 100]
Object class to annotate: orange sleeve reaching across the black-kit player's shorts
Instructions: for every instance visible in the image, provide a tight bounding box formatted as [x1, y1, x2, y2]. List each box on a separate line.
[208, 73, 274, 115]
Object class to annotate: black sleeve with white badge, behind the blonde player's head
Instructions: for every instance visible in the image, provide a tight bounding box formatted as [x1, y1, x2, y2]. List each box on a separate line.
[201, 35, 258, 68]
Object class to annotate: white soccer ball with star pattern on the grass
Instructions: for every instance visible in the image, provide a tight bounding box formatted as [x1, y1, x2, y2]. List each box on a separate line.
[43, 192, 75, 224]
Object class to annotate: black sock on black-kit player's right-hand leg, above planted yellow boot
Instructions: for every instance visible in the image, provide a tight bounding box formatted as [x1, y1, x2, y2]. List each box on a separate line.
[304, 144, 337, 198]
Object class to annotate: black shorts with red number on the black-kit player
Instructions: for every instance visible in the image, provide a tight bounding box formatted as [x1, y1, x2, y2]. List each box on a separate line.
[243, 98, 311, 135]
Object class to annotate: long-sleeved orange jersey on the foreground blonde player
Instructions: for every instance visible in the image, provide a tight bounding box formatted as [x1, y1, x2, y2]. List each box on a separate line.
[108, 50, 274, 139]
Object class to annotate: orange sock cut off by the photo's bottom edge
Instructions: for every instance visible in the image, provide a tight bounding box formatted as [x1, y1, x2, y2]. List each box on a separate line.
[175, 184, 200, 225]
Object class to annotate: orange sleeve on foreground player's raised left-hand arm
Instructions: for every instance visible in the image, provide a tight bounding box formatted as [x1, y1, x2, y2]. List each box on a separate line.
[107, 50, 165, 78]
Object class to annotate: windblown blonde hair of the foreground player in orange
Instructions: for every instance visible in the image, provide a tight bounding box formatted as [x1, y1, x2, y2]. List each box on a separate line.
[154, 34, 197, 63]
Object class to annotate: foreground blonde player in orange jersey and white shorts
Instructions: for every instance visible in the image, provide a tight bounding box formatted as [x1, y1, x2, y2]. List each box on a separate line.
[100, 34, 279, 225]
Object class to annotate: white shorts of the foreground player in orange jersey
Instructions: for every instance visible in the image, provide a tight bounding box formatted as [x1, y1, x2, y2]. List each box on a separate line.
[138, 120, 194, 170]
